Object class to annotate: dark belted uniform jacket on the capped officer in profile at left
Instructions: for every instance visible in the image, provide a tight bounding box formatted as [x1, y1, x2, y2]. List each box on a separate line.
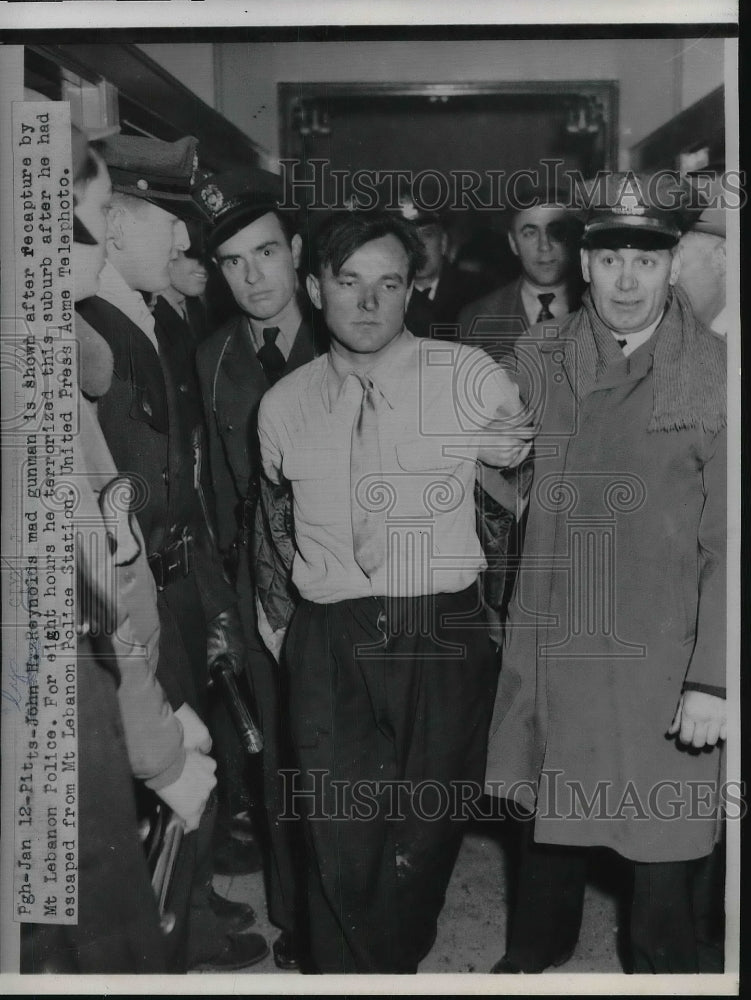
[78, 296, 236, 709]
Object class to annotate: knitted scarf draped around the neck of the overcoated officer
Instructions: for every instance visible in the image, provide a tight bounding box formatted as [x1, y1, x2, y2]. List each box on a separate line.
[561, 287, 727, 433]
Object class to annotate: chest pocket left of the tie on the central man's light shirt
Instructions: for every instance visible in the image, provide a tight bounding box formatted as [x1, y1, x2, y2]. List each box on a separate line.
[282, 447, 340, 525]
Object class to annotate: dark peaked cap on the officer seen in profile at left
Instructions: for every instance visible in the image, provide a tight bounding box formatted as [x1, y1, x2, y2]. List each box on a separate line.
[101, 135, 210, 219]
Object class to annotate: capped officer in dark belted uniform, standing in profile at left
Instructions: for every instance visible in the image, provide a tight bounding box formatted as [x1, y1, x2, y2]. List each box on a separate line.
[76, 136, 268, 971]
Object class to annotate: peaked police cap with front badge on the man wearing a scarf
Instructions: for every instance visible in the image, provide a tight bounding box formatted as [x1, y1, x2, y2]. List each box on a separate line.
[580, 171, 706, 250]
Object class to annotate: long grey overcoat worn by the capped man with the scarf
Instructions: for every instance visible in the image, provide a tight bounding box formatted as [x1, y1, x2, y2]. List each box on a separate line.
[487, 314, 726, 862]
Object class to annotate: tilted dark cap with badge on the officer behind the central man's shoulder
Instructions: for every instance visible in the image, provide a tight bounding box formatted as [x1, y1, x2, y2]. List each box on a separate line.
[193, 167, 288, 253]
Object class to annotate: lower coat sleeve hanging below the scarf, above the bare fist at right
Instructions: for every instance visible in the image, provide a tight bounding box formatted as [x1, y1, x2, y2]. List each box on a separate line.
[684, 430, 727, 696]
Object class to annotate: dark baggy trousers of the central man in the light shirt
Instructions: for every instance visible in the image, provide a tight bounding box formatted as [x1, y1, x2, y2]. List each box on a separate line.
[287, 587, 497, 973]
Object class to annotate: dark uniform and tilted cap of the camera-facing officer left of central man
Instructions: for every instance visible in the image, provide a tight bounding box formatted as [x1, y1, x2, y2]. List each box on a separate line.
[196, 172, 316, 968]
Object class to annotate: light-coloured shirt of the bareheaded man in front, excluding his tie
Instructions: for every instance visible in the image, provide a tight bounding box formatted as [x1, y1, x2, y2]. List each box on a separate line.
[258, 330, 522, 604]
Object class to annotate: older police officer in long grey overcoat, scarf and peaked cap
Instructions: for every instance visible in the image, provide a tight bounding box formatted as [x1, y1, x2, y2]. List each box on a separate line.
[487, 173, 727, 973]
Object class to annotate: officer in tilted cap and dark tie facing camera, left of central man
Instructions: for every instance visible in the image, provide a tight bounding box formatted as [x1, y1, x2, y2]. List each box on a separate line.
[197, 173, 315, 968]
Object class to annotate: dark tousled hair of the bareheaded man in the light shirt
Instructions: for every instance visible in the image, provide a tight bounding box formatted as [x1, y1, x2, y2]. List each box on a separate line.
[310, 212, 425, 282]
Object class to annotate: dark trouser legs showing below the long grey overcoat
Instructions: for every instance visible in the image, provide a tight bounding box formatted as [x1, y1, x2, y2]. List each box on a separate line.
[506, 819, 721, 973]
